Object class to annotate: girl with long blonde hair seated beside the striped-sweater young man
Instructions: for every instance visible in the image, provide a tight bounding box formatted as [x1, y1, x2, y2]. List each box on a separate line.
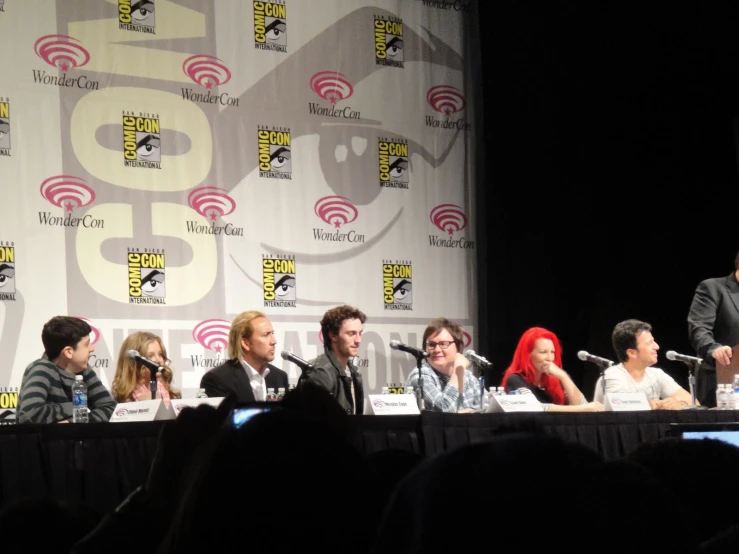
[111, 331, 180, 406]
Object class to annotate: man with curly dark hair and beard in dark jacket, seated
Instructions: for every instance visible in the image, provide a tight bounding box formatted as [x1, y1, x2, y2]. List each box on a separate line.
[298, 306, 367, 414]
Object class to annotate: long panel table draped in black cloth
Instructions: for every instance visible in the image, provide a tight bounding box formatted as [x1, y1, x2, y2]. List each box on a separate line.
[0, 410, 739, 512]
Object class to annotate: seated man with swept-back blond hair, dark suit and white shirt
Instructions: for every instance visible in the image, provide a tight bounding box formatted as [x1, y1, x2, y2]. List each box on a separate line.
[200, 310, 289, 402]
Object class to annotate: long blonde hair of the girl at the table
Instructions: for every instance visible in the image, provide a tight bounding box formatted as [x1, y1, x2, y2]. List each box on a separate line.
[111, 331, 180, 402]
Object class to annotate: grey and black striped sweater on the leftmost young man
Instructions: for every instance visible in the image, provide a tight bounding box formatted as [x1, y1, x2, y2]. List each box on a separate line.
[18, 358, 115, 423]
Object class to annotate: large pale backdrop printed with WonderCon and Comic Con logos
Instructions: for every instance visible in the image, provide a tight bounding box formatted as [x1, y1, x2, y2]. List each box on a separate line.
[0, 0, 481, 408]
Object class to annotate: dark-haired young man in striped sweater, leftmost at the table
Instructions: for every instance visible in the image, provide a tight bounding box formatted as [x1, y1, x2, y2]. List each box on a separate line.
[18, 316, 115, 423]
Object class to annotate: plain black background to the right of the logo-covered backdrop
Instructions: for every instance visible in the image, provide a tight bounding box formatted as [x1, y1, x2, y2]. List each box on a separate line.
[477, 0, 739, 398]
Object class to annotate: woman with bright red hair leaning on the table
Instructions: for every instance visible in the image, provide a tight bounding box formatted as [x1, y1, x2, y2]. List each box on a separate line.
[502, 327, 603, 412]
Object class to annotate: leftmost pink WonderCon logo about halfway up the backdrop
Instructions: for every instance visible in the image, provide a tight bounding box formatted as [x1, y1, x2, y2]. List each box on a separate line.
[38, 175, 105, 229]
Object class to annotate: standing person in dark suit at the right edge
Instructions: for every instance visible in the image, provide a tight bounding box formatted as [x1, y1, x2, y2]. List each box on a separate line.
[688, 253, 739, 407]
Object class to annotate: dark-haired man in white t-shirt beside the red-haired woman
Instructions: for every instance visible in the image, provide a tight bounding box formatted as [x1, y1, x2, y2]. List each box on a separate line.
[595, 319, 691, 410]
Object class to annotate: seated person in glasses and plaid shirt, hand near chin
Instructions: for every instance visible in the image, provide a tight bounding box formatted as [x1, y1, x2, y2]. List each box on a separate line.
[406, 318, 486, 413]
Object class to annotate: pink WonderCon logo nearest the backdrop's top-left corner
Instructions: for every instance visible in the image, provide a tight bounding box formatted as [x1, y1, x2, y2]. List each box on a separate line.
[33, 35, 100, 90]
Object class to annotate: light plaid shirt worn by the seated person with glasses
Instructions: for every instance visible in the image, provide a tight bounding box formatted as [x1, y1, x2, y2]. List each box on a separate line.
[405, 362, 488, 413]
